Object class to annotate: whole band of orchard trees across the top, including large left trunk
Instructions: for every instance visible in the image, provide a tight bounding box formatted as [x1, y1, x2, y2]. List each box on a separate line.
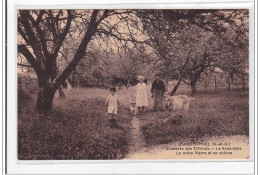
[18, 10, 248, 110]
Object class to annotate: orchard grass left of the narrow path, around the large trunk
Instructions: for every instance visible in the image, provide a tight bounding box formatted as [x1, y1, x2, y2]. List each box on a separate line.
[18, 88, 131, 160]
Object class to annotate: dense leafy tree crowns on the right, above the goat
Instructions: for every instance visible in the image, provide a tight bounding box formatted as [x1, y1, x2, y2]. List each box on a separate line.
[137, 10, 248, 95]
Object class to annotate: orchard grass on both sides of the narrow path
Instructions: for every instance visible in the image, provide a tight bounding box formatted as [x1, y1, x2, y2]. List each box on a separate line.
[18, 78, 249, 160]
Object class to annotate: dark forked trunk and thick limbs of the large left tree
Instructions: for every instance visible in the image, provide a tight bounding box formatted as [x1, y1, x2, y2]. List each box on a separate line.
[18, 10, 113, 110]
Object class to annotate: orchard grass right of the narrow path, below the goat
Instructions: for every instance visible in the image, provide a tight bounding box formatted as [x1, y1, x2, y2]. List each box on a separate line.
[139, 86, 249, 146]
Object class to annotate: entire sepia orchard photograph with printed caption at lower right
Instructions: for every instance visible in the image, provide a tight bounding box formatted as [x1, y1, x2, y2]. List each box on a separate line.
[15, 9, 249, 160]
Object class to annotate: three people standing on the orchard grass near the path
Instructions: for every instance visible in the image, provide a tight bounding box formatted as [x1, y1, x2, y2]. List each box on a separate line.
[106, 74, 165, 126]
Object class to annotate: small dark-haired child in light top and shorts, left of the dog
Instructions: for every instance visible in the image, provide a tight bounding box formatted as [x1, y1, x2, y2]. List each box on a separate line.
[106, 87, 119, 127]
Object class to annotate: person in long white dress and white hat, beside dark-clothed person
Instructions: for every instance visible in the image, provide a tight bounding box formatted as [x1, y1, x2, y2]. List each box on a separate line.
[136, 76, 148, 112]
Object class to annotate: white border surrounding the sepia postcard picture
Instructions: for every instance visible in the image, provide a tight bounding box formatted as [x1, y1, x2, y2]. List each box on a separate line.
[7, 0, 255, 174]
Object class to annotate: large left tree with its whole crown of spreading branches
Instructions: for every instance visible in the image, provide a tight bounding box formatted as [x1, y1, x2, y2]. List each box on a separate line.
[18, 10, 147, 110]
